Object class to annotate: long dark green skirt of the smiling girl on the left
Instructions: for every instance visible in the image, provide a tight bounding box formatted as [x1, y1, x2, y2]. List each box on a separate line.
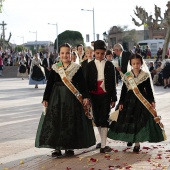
[35, 85, 96, 149]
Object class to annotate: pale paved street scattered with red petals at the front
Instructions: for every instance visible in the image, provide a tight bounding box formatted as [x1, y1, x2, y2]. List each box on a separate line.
[0, 78, 170, 170]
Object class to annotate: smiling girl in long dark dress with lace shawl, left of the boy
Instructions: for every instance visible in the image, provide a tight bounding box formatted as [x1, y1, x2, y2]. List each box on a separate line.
[35, 43, 96, 157]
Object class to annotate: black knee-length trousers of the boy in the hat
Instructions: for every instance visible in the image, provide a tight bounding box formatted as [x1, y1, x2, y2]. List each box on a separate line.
[90, 93, 111, 127]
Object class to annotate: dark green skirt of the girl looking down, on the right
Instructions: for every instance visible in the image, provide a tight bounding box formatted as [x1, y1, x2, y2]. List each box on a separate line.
[108, 90, 164, 143]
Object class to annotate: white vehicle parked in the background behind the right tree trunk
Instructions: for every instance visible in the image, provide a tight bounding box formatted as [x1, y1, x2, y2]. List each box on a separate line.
[138, 39, 170, 58]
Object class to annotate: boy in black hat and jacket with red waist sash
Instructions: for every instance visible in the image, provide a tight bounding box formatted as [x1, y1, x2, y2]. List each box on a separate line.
[86, 40, 117, 153]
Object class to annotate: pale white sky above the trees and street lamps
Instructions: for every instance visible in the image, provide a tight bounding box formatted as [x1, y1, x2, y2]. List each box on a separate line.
[0, 0, 168, 45]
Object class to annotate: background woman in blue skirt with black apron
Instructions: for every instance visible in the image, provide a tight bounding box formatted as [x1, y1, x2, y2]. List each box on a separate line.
[29, 53, 46, 88]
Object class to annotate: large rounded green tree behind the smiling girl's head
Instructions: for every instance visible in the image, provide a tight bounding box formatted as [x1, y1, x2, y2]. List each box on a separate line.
[54, 30, 84, 49]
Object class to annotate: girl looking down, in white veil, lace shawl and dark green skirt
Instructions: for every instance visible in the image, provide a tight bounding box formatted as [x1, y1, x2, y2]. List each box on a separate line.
[108, 54, 164, 152]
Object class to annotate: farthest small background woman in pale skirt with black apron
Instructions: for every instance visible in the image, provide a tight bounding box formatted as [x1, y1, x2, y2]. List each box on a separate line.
[17, 55, 28, 80]
